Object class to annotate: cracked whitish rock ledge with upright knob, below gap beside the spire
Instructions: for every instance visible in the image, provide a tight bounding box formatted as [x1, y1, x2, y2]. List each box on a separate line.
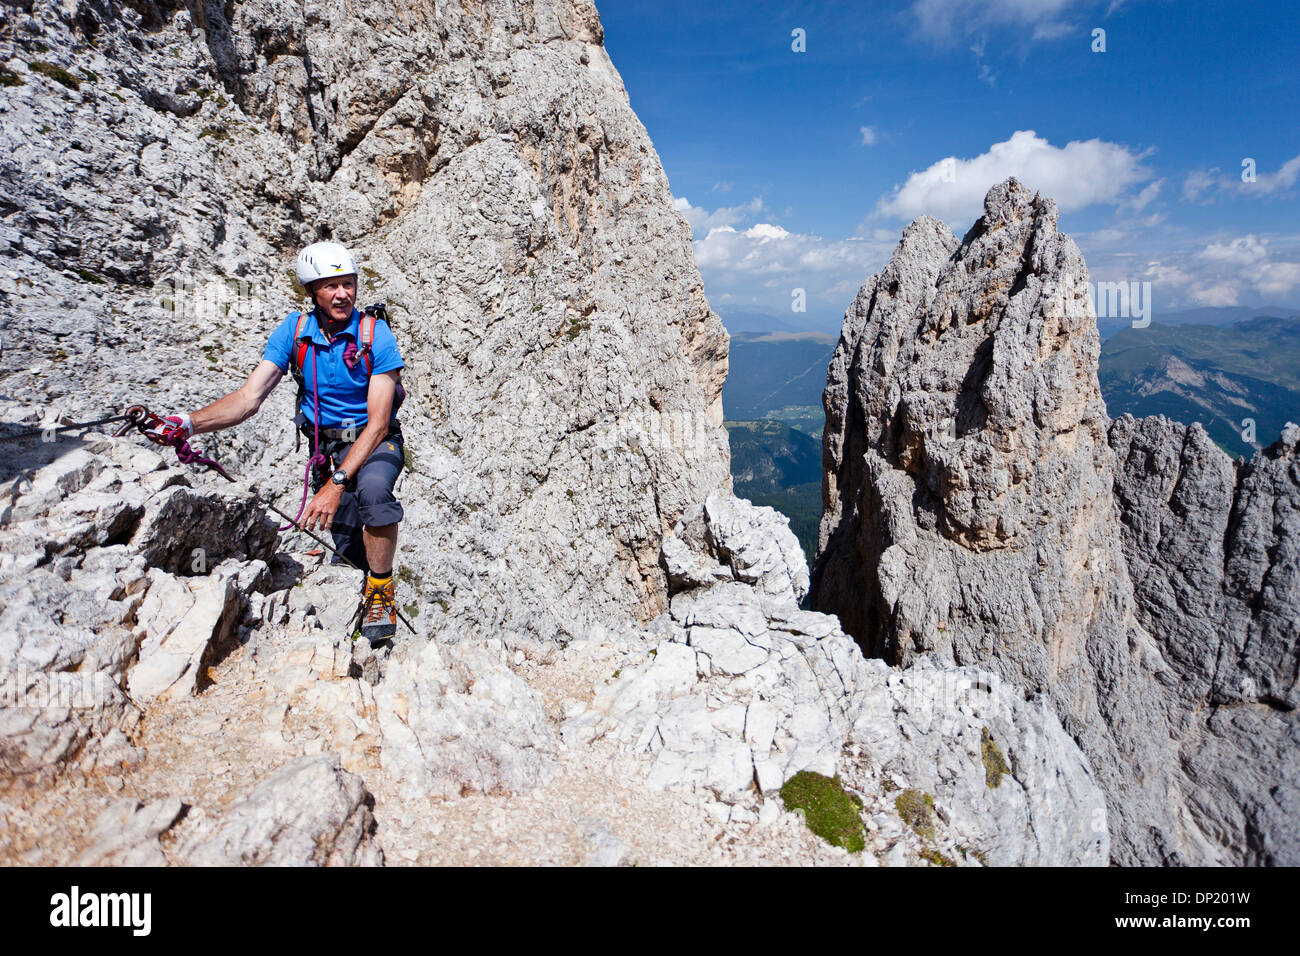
[562, 496, 1109, 865]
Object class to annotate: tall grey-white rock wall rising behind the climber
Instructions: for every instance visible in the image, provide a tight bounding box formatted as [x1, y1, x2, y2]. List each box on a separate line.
[0, 0, 731, 643]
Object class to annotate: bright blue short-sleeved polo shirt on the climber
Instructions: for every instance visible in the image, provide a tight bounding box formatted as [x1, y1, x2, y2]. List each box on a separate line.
[261, 308, 404, 428]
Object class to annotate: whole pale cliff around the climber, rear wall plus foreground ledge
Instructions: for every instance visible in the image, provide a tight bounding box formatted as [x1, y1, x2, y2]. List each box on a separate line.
[0, 0, 1110, 865]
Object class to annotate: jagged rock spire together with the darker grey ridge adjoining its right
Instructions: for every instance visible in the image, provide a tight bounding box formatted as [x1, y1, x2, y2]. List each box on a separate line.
[811, 179, 1300, 864]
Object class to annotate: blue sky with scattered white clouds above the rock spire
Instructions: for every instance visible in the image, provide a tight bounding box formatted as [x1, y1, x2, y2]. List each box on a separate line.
[598, 0, 1300, 332]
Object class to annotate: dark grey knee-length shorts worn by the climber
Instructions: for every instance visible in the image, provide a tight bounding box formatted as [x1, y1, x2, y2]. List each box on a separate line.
[308, 421, 406, 570]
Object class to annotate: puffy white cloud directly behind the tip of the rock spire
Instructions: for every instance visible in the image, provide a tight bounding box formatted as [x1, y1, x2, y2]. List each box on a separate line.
[876, 130, 1158, 225]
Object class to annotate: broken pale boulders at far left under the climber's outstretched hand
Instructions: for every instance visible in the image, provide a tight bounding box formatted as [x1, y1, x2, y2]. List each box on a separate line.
[0, 437, 274, 784]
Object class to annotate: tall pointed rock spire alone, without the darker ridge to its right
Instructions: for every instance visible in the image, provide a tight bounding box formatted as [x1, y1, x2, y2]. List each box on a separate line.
[811, 179, 1179, 864]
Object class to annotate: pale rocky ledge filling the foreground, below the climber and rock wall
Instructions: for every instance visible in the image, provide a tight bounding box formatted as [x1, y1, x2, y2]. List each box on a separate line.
[0, 437, 1109, 865]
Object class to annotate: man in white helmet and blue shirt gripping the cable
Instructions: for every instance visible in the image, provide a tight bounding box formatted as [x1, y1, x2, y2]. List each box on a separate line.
[152, 242, 403, 644]
